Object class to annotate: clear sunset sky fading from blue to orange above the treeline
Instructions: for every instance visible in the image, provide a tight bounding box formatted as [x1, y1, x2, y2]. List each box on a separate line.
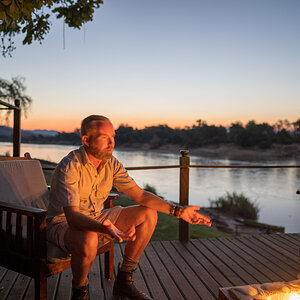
[0, 0, 300, 131]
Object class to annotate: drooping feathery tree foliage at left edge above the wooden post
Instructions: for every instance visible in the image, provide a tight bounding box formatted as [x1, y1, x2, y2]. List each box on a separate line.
[0, 77, 32, 121]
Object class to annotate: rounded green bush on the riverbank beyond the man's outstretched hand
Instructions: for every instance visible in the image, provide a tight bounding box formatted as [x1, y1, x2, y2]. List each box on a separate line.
[209, 192, 259, 220]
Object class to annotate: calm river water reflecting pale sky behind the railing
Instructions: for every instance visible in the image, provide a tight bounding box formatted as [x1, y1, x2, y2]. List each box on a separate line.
[0, 143, 300, 233]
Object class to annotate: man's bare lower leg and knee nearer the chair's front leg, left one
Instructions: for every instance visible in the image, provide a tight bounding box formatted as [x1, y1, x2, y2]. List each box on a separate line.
[64, 228, 98, 288]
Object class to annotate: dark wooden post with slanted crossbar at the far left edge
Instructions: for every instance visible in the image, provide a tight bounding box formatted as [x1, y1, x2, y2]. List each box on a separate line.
[0, 100, 21, 157]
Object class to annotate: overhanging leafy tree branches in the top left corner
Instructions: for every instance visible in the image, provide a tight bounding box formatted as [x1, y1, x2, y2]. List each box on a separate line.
[0, 0, 103, 57]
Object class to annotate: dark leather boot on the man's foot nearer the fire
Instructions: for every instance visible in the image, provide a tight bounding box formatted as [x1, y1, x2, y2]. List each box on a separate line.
[113, 269, 153, 300]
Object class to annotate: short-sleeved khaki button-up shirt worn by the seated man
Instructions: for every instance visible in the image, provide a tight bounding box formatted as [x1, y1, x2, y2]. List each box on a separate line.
[47, 146, 136, 218]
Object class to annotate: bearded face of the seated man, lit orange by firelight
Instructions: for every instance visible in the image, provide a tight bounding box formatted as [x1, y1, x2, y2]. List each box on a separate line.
[85, 121, 115, 160]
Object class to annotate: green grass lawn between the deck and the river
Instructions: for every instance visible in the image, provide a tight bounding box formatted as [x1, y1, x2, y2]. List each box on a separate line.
[114, 195, 228, 241]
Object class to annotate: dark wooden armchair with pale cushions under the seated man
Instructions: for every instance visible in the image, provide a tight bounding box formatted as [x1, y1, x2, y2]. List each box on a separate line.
[0, 156, 118, 299]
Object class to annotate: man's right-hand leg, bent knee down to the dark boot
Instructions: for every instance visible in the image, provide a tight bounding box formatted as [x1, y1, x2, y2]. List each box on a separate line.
[113, 206, 157, 299]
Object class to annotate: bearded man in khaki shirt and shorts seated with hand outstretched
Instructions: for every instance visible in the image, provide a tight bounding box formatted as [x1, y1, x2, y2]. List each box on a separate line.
[47, 115, 211, 300]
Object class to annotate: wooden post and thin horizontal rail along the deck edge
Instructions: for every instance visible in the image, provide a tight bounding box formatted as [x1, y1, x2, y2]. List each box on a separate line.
[43, 150, 300, 243]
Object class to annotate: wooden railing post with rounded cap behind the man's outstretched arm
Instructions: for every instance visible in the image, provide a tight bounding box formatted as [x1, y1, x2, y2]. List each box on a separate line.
[179, 150, 190, 243]
